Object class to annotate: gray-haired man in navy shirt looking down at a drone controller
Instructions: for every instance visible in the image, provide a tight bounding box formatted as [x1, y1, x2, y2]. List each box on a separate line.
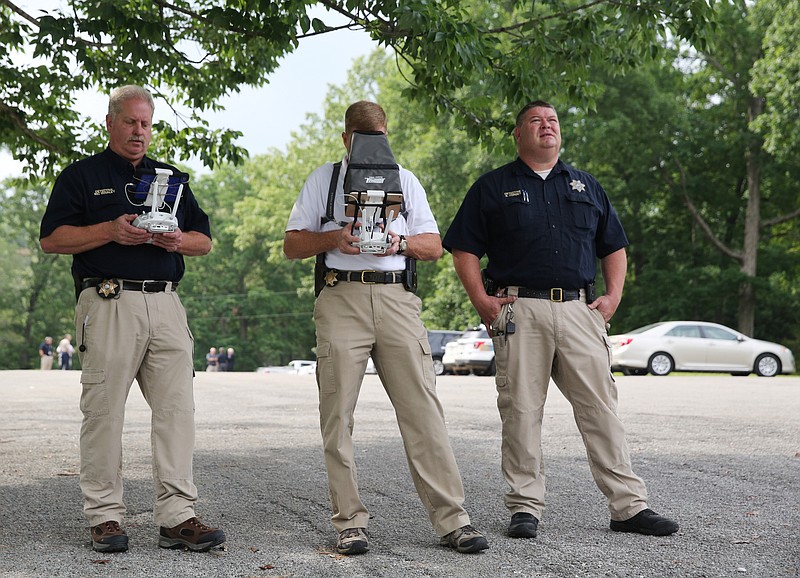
[40, 86, 225, 552]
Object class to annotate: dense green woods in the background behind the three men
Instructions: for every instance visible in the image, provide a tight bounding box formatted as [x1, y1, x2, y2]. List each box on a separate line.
[0, 0, 800, 370]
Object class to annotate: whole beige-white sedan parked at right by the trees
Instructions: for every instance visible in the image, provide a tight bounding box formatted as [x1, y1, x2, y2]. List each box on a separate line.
[609, 321, 795, 377]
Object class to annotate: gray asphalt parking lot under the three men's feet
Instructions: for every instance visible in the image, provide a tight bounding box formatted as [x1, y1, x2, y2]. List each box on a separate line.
[0, 371, 800, 578]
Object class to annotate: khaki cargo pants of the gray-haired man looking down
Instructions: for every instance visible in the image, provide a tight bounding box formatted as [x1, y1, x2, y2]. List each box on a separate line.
[75, 289, 197, 527]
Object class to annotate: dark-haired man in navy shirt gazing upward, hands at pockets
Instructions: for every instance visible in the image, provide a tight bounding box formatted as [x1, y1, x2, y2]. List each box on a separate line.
[443, 101, 678, 538]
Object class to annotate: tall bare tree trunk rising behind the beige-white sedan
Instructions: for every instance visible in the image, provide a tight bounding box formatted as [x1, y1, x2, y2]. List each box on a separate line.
[739, 97, 764, 337]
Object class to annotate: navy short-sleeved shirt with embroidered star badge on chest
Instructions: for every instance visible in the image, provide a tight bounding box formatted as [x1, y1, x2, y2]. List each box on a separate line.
[442, 158, 628, 289]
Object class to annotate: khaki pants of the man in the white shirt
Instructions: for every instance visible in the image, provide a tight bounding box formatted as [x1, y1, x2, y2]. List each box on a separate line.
[314, 282, 469, 536]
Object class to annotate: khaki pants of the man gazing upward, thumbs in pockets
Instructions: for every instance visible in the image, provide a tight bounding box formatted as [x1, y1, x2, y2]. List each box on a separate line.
[493, 298, 647, 520]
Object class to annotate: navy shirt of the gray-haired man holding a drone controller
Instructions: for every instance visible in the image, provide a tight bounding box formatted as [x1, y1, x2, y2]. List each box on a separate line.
[39, 148, 211, 282]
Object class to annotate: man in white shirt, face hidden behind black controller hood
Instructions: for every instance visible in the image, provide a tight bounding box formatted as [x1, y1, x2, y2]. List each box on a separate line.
[283, 101, 489, 555]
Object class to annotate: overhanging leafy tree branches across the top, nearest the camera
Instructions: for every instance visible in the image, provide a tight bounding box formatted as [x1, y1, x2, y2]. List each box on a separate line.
[0, 0, 711, 176]
